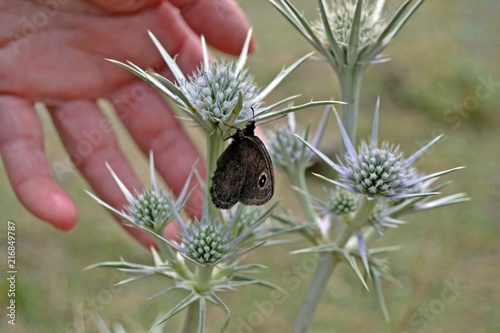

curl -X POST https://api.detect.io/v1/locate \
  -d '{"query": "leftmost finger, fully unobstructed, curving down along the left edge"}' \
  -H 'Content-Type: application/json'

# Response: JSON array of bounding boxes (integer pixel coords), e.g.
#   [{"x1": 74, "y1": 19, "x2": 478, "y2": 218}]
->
[{"x1": 0, "y1": 96, "x2": 78, "y2": 230}]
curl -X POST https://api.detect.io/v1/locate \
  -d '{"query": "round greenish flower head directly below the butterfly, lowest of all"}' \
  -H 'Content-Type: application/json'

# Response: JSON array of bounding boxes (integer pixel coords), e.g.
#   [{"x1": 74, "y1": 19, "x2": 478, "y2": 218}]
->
[{"x1": 182, "y1": 223, "x2": 231, "y2": 265}]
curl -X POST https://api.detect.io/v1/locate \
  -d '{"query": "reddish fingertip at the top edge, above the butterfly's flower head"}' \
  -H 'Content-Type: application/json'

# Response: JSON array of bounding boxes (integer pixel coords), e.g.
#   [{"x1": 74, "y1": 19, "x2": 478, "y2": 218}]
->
[{"x1": 170, "y1": 0, "x2": 256, "y2": 55}]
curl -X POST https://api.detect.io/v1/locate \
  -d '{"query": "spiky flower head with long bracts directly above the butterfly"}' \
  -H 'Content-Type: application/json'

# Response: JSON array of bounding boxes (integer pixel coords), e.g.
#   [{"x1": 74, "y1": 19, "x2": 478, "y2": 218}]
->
[{"x1": 108, "y1": 29, "x2": 336, "y2": 135}]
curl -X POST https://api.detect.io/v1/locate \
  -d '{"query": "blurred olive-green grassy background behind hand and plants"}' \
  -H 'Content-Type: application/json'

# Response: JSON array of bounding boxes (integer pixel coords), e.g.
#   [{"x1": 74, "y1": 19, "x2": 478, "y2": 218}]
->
[{"x1": 0, "y1": 0, "x2": 500, "y2": 333}]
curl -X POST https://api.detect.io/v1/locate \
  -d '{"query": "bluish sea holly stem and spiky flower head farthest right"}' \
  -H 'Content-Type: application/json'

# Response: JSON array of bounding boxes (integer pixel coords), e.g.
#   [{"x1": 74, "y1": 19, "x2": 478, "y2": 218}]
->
[{"x1": 286, "y1": 103, "x2": 468, "y2": 332}]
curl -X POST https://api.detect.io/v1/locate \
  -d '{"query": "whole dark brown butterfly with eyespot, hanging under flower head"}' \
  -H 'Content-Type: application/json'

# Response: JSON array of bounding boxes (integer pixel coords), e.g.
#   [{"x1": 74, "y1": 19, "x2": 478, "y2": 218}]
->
[{"x1": 210, "y1": 121, "x2": 274, "y2": 209}]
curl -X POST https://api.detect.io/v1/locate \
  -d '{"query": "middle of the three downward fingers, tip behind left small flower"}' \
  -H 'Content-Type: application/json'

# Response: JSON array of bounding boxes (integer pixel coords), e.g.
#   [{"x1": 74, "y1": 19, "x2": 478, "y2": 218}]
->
[{"x1": 49, "y1": 100, "x2": 153, "y2": 245}]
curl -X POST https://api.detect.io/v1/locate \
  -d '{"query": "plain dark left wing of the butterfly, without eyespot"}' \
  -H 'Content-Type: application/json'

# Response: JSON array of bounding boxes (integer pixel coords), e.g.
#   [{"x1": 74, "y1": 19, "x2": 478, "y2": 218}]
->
[{"x1": 210, "y1": 139, "x2": 248, "y2": 209}]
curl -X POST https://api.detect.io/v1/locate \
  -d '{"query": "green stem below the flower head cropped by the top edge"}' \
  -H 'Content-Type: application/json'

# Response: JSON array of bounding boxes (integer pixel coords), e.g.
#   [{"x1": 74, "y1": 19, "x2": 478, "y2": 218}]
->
[{"x1": 339, "y1": 65, "x2": 365, "y2": 158}]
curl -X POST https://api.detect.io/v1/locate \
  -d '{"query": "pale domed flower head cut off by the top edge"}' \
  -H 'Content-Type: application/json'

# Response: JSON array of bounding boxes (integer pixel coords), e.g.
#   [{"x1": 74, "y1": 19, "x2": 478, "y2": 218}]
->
[{"x1": 311, "y1": 0, "x2": 388, "y2": 47}]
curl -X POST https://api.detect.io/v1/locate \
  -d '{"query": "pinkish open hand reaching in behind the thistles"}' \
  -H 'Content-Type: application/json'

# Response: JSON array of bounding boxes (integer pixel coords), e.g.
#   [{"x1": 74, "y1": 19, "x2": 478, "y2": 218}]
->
[{"x1": 0, "y1": 0, "x2": 255, "y2": 244}]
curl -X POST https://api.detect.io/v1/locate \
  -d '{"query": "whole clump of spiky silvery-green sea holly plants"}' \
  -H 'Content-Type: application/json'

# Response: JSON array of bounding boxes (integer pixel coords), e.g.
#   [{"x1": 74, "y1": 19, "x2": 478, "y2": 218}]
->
[{"x1": 86, "y1": 0, "x2": 468, "y2": 333}]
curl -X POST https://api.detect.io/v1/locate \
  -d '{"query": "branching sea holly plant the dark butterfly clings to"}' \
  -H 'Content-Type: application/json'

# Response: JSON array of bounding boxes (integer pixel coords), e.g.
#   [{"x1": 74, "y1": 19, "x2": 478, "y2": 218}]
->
[{"x1": 89, "y1": 31, "x2": 337, "y2": 333}]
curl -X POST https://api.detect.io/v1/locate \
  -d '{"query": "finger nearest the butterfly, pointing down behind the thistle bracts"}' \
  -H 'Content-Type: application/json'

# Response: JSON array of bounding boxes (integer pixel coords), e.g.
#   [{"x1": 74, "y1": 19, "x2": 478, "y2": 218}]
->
[{"x1": 109, "y1": 81, "x2": 205, "y2": 217}]
